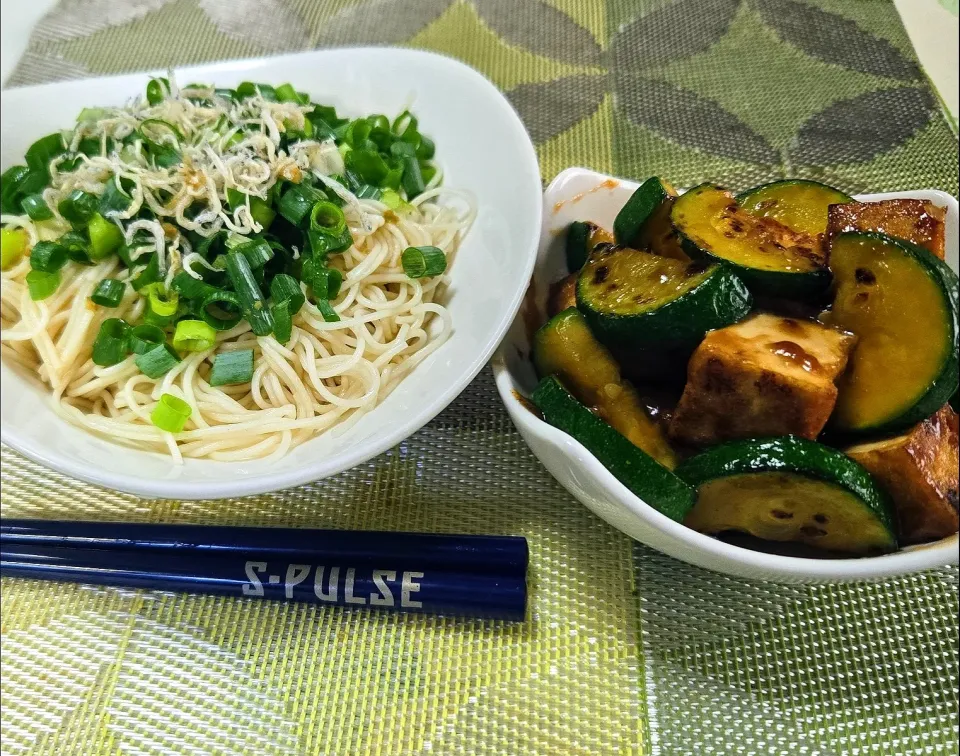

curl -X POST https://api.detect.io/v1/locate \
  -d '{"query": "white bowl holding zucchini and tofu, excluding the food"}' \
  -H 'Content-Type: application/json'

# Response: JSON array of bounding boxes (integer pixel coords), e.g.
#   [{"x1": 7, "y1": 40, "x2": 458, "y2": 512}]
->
[{"x1": 493, "y1": 168, "x2": 958, "y2": 583}]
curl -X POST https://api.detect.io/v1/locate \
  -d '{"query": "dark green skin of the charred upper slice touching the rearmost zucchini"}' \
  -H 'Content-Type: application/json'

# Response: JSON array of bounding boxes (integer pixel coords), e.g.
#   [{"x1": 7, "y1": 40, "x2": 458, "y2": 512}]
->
[{"x1": 670, "y1": 184, "x2": 832, "y2": 300}]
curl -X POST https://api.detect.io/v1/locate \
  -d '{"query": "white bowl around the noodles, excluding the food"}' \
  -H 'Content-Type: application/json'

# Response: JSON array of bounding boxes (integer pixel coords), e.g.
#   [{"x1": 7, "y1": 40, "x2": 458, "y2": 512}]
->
[{"x1": 0, "y1": 48, "x2": 542, "y2": 499}]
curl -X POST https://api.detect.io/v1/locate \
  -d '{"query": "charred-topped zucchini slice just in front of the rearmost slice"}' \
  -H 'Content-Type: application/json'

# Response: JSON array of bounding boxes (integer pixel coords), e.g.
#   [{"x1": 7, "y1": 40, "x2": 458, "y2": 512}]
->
[{"x1": 670, "y1": 184, "x2": 830, "y2": 299}]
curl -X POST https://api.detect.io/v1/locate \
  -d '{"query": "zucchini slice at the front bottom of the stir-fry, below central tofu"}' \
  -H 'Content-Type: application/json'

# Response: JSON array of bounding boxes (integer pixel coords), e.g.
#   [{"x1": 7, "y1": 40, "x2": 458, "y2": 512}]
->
[{"x1": 677, "y1": 436, "x2": 897, "y2": 554}]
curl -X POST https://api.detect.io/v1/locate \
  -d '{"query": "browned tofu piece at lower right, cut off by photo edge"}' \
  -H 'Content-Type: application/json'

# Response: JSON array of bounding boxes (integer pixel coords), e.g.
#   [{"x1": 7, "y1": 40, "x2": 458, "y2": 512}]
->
[{"x1": 846, "y1": 405, "x2": 960, "y2": 544}]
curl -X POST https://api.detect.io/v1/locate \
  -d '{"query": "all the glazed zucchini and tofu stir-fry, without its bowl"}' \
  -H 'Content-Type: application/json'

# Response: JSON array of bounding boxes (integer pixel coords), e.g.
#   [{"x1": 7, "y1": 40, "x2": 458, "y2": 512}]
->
[{"x1": 533, "y1": 178, "x2": 960, "y2": 556}]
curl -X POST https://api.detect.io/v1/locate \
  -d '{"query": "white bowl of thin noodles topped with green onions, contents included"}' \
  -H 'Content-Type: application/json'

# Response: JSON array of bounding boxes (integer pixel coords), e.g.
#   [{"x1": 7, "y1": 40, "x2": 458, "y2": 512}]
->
[{"x1": 0, "y1": 48, "x2": 541, "y2": 499}]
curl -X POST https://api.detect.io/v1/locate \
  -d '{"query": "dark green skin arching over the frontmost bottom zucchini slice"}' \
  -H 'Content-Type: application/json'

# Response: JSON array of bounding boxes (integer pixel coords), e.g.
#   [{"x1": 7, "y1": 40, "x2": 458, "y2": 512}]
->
[{"x1": 676, "y1": 436, "x2": 897, "y2": 541}]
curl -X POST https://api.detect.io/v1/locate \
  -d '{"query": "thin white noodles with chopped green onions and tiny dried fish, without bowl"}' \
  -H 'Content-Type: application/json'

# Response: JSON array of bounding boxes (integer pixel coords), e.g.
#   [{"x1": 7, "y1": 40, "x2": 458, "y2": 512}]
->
[{"x1": 0, "y1": 77, "x2": 475, "y2": 461}]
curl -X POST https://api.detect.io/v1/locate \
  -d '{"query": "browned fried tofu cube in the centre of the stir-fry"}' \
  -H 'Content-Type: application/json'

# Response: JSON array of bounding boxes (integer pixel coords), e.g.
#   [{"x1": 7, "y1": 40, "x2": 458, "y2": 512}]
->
[{"x1": 670, "y1": 313, "x2": 856, "y2": 446}]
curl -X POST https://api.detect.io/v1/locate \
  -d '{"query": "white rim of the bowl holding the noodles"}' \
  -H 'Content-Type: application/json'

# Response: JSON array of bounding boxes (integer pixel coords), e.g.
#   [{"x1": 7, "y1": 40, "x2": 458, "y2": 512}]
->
[{"x1": 0, "y1": 46, "x2": 543, "y2": 500}]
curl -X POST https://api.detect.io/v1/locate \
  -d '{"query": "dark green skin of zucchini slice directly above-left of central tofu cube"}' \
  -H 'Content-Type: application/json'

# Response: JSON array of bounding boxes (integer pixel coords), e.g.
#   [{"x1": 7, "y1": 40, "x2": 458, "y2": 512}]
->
[{"x1": 577, "y1": 255, "x2": 753, "y2": 349}]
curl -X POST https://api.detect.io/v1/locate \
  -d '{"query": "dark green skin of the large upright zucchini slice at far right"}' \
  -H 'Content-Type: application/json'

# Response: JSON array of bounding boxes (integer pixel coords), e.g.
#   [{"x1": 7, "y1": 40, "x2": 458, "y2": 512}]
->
[{"x1": 831, "y1": 231, "x2": 960, "y2": 437}]
